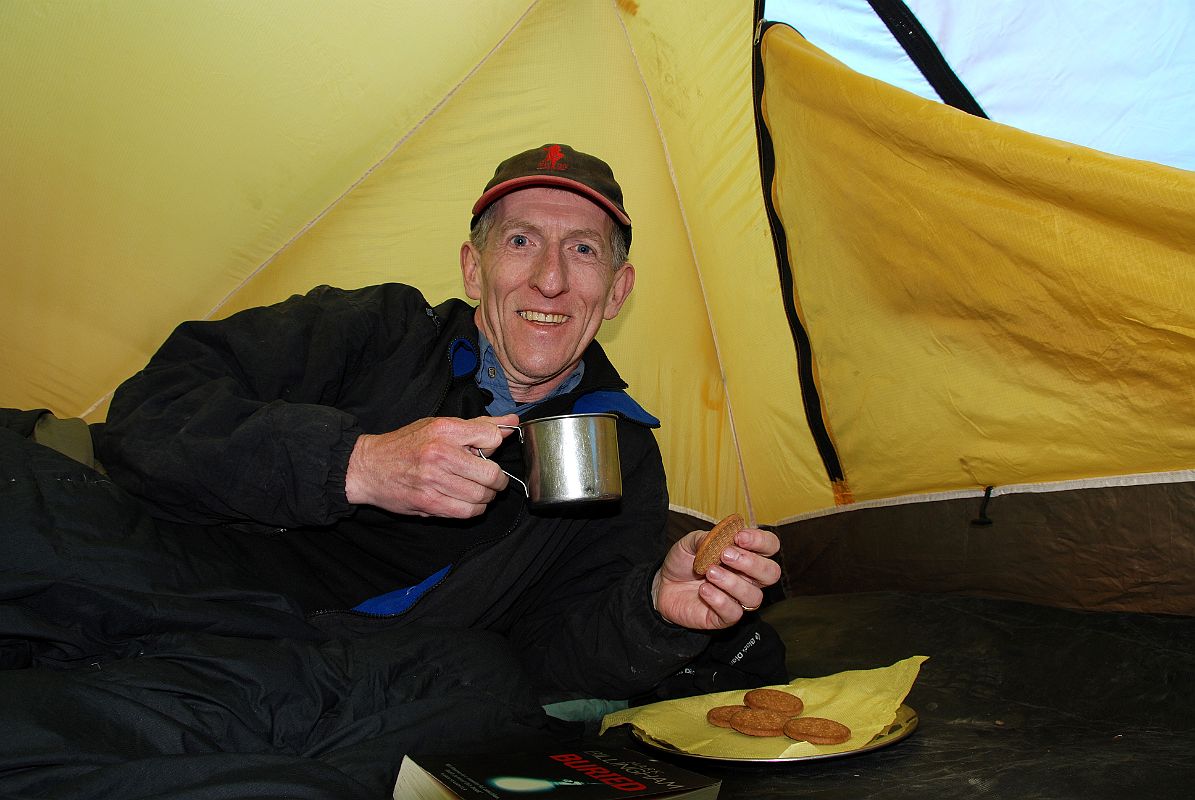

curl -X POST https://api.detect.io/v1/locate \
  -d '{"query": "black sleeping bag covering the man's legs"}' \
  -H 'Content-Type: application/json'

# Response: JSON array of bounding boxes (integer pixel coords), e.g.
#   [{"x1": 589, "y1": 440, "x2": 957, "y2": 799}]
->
[{"x1": 0, "y1": 413, "x2": 580, "y2": 800}]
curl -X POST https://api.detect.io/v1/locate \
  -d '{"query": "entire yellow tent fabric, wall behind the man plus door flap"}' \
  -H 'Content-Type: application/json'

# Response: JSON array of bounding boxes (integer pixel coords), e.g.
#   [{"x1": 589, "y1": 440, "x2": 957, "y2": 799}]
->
[{"x1": 0, "y1": 0, "x2": 1195, "y2": 524}]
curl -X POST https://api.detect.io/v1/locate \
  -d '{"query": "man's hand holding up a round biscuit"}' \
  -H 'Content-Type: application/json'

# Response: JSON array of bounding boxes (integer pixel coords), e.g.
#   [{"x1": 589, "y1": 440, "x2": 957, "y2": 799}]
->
[{"x1": 651, "y1": 527, "x2": 780, "y2": 630}]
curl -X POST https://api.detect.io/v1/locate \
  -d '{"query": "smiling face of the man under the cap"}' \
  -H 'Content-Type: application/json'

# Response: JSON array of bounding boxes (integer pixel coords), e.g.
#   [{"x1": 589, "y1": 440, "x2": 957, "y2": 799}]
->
[{"x1": 460, "y1": 188, "x2": 635, "y2": 402}]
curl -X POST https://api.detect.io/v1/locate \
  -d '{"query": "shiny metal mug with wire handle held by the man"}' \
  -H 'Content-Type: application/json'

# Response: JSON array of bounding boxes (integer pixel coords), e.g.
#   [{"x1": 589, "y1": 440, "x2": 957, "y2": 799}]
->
[{"x1": 478, "y1": 414, "x2": 623, "y2": 507}]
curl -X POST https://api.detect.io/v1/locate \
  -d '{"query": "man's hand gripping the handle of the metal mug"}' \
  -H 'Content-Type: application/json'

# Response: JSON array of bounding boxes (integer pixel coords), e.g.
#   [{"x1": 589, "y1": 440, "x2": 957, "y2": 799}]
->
[{"x1": 344, "y1": 414, "x2": 519, "y2": 519}]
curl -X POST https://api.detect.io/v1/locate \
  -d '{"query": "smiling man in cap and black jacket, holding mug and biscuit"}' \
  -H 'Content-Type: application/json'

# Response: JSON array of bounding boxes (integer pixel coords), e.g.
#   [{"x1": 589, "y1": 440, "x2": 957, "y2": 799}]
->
[{"x1": 102, "y1": 145, "x2": 778, "y2": 640}]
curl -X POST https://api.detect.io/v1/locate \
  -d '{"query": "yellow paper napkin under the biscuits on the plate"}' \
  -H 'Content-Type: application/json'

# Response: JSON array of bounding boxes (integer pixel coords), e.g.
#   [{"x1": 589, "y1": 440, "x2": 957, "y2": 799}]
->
[{"x1": 601, "y1": 655, "x2": 929, "y2": 758}]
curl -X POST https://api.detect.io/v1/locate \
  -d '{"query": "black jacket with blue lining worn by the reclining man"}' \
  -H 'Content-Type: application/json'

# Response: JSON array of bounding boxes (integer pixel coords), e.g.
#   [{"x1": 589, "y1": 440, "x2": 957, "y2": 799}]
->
[{"x1": 97, "y1": 283, "x2": 709, "y2": 697}]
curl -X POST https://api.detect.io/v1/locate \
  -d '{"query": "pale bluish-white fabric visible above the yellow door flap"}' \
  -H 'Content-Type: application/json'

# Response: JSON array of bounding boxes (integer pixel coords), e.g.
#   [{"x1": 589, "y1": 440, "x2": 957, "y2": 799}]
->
[{"x1": 767, "y1": 0, "x2": 1195, "y2": 170}]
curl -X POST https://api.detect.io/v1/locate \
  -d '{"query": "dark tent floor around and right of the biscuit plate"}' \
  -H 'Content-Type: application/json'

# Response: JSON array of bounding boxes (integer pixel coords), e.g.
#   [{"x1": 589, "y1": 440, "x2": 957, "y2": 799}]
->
[{"x1": 602, "y1": 593, "x2": 1195, "y2": 800}]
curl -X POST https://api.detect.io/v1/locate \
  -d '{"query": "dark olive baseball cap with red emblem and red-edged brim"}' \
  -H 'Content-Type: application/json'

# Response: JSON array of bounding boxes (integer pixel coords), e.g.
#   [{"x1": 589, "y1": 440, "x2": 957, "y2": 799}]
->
[{"x1": 470, "y1": 145, "x2": 631, "y2": 246}]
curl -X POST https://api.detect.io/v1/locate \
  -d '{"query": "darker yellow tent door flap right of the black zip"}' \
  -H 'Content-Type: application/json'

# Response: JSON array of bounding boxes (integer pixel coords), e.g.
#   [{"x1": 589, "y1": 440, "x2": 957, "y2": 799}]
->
[{"x1": 764, "y1": 28, "x2": 1195, "y2": 511}]
